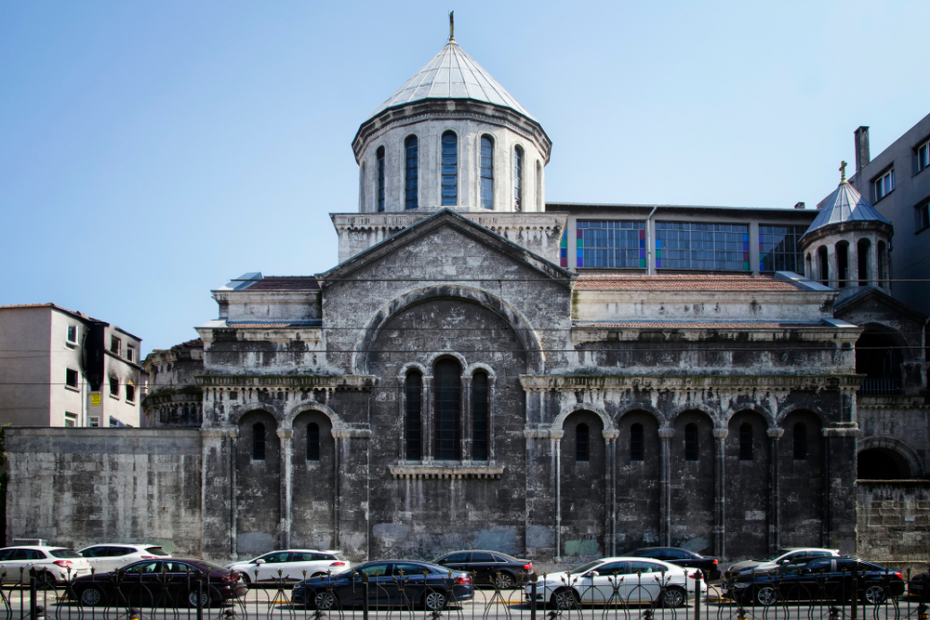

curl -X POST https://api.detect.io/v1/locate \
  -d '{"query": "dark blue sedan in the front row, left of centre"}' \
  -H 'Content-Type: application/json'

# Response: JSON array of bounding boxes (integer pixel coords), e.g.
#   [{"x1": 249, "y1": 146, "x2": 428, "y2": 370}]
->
[{"x1": 291, "y1": 560, "x2": 475, "y2": 611}]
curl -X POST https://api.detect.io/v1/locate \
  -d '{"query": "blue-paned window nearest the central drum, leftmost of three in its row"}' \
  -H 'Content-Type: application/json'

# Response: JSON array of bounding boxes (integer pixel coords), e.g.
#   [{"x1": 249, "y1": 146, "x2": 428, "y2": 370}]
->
[{"x1": 575, "y1": 220, "x2": 646, "y2": 269}]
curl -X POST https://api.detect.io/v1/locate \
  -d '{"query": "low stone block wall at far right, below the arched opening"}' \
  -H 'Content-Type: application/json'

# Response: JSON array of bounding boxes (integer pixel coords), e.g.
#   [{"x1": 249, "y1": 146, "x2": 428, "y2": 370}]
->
[{"x1": 856, "y1": 480, "x2": 930, "y2": 571}]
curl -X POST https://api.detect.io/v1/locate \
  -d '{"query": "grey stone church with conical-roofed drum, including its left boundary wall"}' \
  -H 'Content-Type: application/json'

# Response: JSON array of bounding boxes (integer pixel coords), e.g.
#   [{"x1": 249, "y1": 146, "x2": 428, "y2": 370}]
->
[{"x1": 7, "y1": 38, "x2": 930, "y2": 562}]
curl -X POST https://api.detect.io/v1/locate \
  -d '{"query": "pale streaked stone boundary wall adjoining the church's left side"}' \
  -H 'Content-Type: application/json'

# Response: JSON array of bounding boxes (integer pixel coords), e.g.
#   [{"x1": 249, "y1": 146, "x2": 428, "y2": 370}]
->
[{"x1": 6, "y1": 427, "x2": 202, "y2": 556}]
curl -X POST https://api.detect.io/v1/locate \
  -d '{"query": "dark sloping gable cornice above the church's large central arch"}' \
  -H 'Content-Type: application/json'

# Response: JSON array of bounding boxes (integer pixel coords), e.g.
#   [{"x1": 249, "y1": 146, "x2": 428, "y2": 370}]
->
[{"x1": 316, "y1": 209, "x2": 574, "y2": 288}]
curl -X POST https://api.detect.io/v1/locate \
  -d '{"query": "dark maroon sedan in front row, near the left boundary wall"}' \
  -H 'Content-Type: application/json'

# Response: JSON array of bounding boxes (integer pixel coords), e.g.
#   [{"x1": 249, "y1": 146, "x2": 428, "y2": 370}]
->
[{"x1": 73, "y1": 558, "x2": 248, "y2": 607}]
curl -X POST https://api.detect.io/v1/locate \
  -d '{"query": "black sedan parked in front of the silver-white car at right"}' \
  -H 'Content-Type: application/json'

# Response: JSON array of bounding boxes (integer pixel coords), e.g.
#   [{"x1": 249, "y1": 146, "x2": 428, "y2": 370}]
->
[{"x1": 726, "y1": 556, "x2": 904, "y2": 605}]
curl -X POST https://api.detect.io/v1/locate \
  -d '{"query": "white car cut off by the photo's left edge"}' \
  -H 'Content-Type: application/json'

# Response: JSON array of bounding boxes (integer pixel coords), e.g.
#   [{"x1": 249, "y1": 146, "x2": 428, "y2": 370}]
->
[{"x1": 0, "y1": 545, "x2": 90, "y2": 587}]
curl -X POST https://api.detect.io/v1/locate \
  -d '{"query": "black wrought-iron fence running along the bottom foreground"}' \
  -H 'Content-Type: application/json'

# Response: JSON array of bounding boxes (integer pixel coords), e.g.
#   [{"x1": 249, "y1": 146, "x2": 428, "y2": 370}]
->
[{"x1": 0, "y1": 571, "x2": 930, "y2": 620}]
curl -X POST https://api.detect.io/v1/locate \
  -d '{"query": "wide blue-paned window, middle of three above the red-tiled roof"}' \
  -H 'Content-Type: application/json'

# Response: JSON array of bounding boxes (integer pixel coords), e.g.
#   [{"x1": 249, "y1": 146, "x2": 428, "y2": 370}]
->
[{"x1": 656, "y1": 222, "x2": 749, "y2": 271}]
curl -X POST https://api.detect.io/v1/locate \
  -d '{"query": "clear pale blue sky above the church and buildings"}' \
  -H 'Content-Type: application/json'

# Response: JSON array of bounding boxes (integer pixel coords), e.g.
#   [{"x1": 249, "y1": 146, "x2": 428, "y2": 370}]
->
[{"x1": 0, "y1": 0, "x2": 930, "y2": 352}]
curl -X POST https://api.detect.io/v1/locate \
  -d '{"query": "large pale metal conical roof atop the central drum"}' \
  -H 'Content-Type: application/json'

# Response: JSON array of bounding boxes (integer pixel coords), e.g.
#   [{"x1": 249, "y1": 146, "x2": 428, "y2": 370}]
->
[{"x1": 369, "y1": 40, "x2": 536, "y2": 121}]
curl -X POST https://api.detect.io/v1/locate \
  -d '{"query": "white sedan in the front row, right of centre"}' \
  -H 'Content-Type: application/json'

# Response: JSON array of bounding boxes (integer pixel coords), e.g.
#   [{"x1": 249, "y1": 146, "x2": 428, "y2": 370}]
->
[{"x1": 526, "y1": 557, "x2": 707, "y2": 609}]
